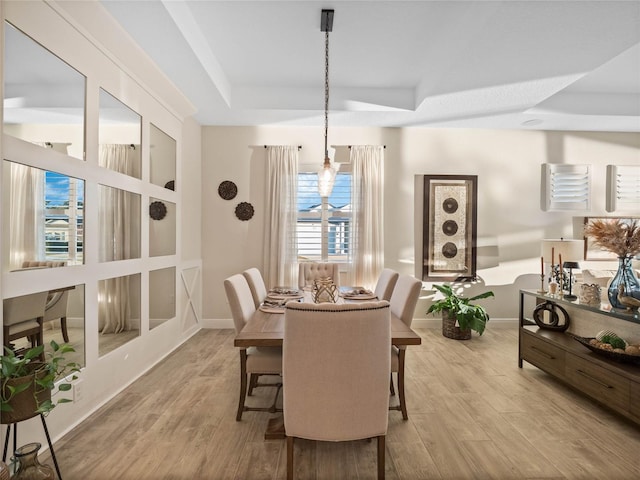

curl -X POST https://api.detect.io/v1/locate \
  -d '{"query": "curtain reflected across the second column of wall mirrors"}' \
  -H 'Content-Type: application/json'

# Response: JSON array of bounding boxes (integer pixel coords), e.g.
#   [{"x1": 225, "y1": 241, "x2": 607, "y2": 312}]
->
[{"x1": 98, "y1": 145, "x2": 135, "y2": 333}]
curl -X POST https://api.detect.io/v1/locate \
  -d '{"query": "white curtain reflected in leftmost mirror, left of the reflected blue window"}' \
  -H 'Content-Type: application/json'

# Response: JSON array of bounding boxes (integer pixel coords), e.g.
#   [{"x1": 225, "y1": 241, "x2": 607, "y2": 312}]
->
[{"x1": 5, "y1": 162, "x2": 45, "y2": 270}]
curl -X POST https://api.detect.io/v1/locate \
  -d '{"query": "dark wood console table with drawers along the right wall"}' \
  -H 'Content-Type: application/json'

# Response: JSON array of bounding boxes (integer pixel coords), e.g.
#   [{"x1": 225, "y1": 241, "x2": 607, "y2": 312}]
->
[{"x1": 518, "y1": 290, "x2": 640, "y2": 425}]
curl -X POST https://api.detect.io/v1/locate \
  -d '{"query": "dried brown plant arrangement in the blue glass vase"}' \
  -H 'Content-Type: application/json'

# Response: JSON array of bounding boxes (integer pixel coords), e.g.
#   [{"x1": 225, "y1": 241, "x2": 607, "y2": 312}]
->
[{"x1": 584, "y1": 218, "x2": 640, "y2": 258}]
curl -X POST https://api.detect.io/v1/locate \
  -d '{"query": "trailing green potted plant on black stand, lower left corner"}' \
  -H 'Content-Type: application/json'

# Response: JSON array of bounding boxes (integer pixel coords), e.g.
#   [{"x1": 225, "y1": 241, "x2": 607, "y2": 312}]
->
[{"x1": 0, "y1": 340, "x2": 80, "y2": 424}]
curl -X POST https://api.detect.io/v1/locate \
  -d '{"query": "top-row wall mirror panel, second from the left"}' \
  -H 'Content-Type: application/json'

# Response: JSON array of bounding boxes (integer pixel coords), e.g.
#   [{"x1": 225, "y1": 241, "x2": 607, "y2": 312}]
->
[{"x1": 98, "y1": 89, "x2": 142, "y2": 178}]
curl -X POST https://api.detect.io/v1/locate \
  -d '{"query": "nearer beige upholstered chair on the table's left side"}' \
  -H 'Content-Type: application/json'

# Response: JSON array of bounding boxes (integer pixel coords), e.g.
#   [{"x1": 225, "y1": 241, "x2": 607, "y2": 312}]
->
[{"x1": 224, "y1": 274, "x2": 282, "y2": 421}]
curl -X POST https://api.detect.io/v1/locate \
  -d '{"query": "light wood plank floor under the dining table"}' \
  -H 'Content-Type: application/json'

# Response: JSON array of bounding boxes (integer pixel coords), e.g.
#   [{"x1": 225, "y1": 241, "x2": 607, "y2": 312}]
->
[{"x1": 46, "y1": 327, "x2": 640, "y2": 480}]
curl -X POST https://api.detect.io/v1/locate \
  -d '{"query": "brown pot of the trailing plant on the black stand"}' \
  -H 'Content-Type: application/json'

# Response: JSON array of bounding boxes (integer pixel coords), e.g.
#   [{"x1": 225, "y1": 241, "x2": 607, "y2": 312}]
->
[{"x1": 0, "y1": 363, "x2": 51, "y2": 425}]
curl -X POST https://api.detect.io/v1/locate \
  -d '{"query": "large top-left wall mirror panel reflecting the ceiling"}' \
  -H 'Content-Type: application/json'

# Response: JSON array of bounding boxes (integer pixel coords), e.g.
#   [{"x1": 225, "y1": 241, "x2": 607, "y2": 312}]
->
[{"x1": 3, "y1": 22, "x2": 86, "y2": 159}]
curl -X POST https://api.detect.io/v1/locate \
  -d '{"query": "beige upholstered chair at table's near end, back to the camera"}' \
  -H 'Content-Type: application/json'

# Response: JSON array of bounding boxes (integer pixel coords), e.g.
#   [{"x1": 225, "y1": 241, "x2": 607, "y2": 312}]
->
[{"x1": 282, "y1": 301, "x2": 391, "y2": 479}]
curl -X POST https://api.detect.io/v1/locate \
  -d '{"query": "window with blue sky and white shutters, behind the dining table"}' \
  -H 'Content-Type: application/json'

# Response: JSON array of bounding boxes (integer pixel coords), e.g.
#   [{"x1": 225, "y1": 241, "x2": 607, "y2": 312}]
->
[{"x1": 296, "y1": 172, "x2": 351, "y2": 262}]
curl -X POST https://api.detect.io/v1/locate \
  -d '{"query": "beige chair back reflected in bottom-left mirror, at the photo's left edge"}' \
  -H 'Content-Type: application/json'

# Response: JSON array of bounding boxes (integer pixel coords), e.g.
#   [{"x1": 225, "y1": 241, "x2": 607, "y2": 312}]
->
[{"x1": 2, "y1": 292, "x2": 47, "y2": 354}]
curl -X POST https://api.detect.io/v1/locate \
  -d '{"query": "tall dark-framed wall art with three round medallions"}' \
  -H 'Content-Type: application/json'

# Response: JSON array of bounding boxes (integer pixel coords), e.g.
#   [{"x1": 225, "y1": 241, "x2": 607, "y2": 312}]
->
[{"x1": 422, "y1": 175, "x2": 478, "y2": 282}]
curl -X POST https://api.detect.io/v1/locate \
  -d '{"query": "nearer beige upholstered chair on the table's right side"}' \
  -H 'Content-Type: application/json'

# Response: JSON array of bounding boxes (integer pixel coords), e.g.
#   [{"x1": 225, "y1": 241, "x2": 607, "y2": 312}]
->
[{"x1": 389, "y1": 275, "x2": 422, "y2": 420}]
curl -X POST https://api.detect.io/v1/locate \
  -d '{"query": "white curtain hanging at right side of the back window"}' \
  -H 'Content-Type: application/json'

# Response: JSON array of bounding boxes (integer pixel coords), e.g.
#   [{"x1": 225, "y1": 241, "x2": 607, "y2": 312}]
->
[{"x1": 351, "y1": 145, "x2": 384, "y2": 288}]
